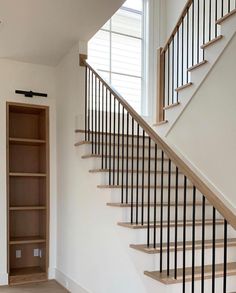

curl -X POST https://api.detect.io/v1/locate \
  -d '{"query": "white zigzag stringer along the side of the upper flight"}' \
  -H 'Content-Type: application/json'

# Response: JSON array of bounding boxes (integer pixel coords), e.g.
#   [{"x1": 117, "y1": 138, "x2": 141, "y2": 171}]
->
[{"x1": 153, "y1": 14, "x2": 236, "y2": 137}]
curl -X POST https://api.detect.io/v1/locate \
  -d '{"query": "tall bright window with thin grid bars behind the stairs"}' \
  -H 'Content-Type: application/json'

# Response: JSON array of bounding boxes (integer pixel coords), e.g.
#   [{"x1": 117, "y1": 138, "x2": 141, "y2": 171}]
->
[{"x1": 88, "y1": 0, "x2": 144, "y2": 113}]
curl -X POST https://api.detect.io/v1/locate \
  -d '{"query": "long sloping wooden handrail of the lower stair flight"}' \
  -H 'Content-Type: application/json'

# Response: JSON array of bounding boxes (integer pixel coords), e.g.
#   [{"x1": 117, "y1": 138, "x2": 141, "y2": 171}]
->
[{"x1": 84, "y1": 60, "x2": 236, "y2": 229}]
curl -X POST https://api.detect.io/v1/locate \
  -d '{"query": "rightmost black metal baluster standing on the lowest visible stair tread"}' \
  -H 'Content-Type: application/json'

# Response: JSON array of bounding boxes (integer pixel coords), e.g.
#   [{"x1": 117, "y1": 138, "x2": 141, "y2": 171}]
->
[{"x1": 175, "y1": 167, "x2": 179, "y2": 279}]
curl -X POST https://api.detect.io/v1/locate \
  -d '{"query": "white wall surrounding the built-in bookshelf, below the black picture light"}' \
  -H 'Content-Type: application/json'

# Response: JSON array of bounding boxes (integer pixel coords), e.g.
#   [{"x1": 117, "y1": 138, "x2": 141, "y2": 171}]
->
[{"x1": 0, "y1": 59, "x2": 56, "y2": 285}]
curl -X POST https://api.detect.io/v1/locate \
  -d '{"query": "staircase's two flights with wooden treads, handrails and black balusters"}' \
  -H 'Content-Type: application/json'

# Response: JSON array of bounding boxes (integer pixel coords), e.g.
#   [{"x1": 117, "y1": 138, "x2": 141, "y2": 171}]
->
[{"x1": 76, "y1": 0, "x2": 236, "y2": 293}]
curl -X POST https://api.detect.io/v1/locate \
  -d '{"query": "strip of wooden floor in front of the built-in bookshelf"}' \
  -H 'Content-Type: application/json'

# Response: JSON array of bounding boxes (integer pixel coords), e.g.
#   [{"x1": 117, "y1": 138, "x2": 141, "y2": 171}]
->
[{"x1": 0, "y1": 281, "x2": 69, "y2": 293}]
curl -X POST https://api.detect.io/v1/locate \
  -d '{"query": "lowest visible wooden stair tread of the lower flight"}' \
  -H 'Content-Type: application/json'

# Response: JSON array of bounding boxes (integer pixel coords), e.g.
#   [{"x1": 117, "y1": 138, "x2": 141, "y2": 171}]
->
[{"x1": 144, "y1": 262, "x2": 236, "y2": 285}]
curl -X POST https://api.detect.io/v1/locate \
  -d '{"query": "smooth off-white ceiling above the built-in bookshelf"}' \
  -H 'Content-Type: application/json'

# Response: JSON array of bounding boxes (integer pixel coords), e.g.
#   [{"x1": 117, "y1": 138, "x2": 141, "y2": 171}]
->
[{"x1": 0, "y1": 0, "x2": 124, "y2": 66}]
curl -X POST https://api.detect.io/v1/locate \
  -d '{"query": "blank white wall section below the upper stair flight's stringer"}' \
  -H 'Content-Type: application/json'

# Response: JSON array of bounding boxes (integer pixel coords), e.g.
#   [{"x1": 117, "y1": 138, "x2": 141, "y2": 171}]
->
[{"x1": 167, "y1": 35, "x2": 236, "y2": 211}]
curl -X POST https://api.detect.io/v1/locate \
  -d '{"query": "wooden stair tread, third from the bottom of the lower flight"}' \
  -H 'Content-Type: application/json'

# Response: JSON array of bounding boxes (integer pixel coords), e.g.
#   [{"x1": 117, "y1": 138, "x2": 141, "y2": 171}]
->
[{"x1": 118, "y1": 219, "x2": 224, "y2": 229}]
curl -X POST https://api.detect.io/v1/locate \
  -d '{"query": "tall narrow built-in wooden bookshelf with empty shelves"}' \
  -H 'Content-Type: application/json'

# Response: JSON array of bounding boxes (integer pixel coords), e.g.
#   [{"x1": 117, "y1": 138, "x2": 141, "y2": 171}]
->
[{"x1": 7, "y1": 103, "x2": 49, "y2": 285}]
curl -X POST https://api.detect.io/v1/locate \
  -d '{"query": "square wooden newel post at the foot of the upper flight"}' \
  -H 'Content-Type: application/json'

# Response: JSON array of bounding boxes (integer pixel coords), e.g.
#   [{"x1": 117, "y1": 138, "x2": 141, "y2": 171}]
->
[{"x1": 157, "y1": 48, "x2": 165, "y2": 123}]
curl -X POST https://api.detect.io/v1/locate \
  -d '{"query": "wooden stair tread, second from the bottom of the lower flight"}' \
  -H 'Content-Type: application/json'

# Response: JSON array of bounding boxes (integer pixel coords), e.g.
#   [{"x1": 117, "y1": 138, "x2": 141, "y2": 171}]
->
[{"x1": 130, "y1": 238, "x2": 236, "y2": 254}]
